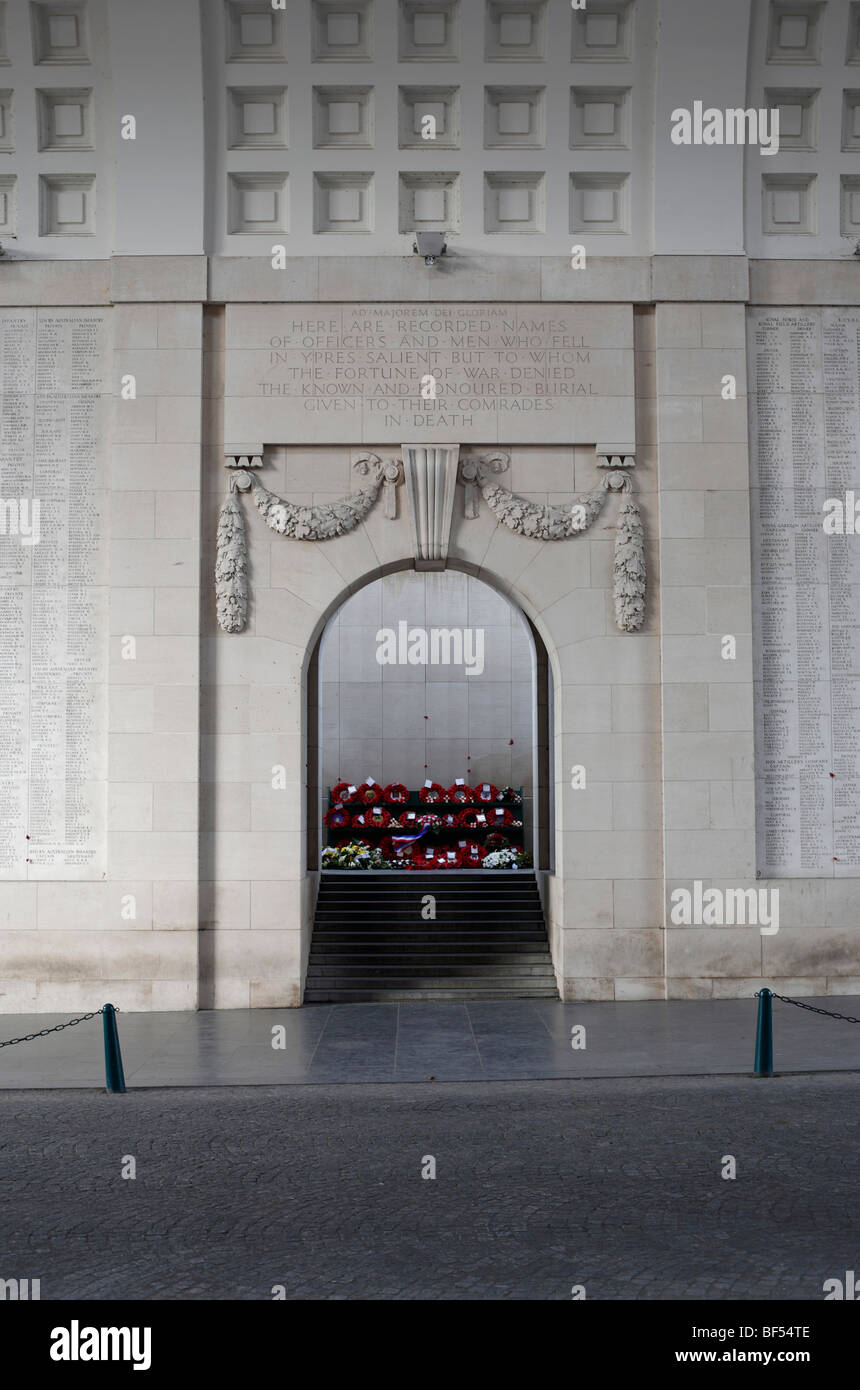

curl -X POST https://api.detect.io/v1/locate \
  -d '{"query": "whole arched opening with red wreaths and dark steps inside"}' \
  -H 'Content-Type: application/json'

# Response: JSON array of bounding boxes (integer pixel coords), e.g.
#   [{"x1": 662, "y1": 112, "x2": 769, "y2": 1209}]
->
[{"x1": 303, "y1": 566, "x2": 559, "y2": 1004}]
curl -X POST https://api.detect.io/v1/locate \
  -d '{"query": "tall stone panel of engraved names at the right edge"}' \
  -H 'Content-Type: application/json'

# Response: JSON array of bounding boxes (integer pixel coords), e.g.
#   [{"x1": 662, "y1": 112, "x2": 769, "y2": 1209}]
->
[{"x1": 749, "y1": 309, "x2": 860, "y2": 877}]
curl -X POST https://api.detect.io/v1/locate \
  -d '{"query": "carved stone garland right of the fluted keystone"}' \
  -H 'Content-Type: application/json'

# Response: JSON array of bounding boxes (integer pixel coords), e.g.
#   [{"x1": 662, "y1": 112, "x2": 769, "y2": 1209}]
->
[{"x1": 460, "y1": 453, "x2": 646, "y2": 632}]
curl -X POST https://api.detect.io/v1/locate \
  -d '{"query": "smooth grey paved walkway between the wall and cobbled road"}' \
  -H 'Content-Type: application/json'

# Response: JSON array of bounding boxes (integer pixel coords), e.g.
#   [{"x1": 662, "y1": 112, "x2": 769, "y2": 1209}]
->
[{"x1": 0, "y1": 995, "x2": 860, "y2": 1088}]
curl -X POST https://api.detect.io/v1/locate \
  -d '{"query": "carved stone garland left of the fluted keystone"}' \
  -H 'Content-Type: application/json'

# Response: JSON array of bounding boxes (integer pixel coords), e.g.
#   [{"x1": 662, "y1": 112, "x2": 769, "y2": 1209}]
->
[{"x1": 215, "y1": 453, "x2": 403, "y2": 632}]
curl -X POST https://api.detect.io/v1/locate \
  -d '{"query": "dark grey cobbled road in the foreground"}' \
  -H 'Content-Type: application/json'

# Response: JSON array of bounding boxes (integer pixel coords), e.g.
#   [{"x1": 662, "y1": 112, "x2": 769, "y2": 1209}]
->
[{"x1": 0, "y1": 1074, "x2": 860, "y2": 1301}]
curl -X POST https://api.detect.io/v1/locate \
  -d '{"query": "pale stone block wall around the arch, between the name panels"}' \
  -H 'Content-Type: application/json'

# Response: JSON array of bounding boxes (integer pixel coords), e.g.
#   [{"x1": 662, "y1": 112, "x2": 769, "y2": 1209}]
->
[{"x1": 0, "y1": 257, "x2": 860, "y2": 1011}]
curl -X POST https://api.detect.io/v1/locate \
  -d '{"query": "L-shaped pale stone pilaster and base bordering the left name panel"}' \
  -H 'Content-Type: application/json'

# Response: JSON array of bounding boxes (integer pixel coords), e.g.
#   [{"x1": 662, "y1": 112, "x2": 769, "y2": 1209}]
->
[{"x1": 0, "y1": 303, "x2": 203, "y2": 1012}]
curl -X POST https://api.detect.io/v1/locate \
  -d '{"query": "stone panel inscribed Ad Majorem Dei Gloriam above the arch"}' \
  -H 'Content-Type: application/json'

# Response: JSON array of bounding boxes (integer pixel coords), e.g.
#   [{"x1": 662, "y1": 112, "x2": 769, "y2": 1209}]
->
[{"x1": 225, "y1": 303, "x2": 635, "y2": 445}]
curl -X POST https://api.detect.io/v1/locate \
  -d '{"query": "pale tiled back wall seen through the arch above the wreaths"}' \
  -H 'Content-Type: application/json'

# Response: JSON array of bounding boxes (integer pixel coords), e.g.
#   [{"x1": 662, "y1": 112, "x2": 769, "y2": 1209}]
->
[{"x1": 307, "y1": 566, "x2": 554, "y2": 872}]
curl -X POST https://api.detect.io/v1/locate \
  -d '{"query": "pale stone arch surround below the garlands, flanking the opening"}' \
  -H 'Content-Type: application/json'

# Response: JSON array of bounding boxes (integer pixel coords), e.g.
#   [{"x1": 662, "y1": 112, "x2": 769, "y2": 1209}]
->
[{"x1": 200, "y1": 448, "x2": 664, "y2": 1008}]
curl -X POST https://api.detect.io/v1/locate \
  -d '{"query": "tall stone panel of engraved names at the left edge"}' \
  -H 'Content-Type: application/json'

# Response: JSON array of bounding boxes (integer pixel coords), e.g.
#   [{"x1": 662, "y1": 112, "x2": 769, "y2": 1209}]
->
[{"x1": 0, "y1": 309, "x2": 107, "y2": 878}]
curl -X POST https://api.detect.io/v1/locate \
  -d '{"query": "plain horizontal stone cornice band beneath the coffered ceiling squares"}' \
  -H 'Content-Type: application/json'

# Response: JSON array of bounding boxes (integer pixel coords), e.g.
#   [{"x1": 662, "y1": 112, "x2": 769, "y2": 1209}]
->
[{"x1": 0, "y1": 258, "x2": 860, "y2": 309}]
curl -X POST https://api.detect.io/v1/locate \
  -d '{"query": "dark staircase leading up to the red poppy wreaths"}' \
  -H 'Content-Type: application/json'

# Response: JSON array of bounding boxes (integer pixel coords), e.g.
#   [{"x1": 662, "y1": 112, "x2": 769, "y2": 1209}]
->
[{"x1": 304, "y1": 870, "x2": 559, "y2": 1004}]
